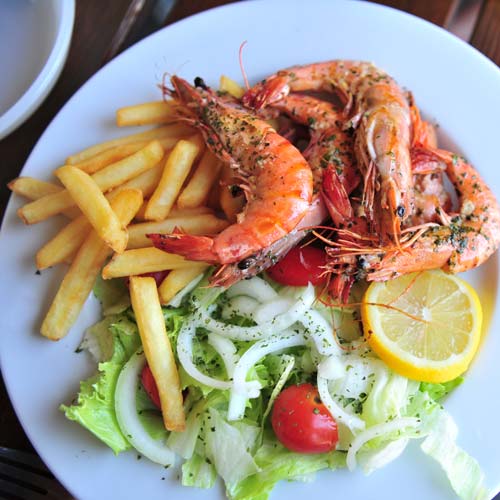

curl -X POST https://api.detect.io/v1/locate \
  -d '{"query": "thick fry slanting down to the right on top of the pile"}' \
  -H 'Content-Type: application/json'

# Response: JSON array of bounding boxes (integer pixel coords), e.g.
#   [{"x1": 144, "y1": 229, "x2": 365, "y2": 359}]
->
[{"x1": 56, "y1": 165, "x2": 128, "y2": 253}]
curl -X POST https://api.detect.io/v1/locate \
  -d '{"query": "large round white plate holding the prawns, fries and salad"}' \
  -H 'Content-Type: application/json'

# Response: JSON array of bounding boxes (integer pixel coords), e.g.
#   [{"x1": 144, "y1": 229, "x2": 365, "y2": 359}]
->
[{"x1": 0, "y1": 0, "x2": 500, "y2": 500}]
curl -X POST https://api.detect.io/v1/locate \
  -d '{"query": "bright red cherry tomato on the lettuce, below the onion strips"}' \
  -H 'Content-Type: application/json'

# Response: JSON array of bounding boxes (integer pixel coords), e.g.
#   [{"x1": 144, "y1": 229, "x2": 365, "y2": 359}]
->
[{"x1": 271, "y1": 384, "x2": 339, "y2": 453}]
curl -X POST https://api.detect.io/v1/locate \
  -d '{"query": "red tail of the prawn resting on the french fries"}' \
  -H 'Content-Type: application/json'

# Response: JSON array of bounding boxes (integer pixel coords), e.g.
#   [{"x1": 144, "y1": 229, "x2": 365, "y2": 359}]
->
[{"x1": 147, "y1": 233, "x2": 219, "y2": 264}]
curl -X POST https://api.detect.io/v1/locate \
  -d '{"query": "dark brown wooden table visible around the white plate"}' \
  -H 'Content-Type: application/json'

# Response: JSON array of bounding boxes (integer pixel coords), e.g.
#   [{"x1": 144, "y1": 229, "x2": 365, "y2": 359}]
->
[{"x1": 0, "y1": 0, "x2": 500, "y2": 498}]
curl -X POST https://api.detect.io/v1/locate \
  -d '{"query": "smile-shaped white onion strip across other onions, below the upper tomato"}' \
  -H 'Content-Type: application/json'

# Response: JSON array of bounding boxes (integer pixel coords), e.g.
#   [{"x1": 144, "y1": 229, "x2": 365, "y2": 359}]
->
[{"x1": 197, "y1": 284, "x2": 315, "y2": 341}]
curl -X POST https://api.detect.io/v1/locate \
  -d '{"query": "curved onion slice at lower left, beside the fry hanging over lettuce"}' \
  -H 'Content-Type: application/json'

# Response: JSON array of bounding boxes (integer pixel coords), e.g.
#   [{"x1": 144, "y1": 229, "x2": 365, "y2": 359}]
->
[{"x1": 115, "y1": 349, "x2": 175, "y2": 466}]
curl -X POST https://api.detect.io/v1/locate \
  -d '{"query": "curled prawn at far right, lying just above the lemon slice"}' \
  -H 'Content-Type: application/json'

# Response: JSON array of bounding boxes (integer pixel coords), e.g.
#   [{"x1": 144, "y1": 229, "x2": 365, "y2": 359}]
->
[{"x1": 327, "y1": 149, "x2": 500, "y2": 281}]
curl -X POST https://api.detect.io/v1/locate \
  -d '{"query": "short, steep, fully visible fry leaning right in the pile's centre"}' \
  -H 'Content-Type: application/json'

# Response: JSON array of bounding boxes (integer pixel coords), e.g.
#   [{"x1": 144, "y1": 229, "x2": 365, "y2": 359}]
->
[{"x1": 145, "y1": 136, "x2": 203, "y2": 221}]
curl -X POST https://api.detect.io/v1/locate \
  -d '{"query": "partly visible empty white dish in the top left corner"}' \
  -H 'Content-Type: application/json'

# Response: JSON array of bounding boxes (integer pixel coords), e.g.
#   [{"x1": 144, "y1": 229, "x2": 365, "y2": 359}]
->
[{"x1": 0, "y1": 0, "x2": 75, "y2": 139}]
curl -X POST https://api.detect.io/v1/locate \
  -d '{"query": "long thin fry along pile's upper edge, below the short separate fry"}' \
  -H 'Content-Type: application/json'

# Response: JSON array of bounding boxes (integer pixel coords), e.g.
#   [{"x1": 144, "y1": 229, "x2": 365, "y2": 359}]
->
[{"x1": 66, "y1": 123, "x2": 193, "y2": 165}]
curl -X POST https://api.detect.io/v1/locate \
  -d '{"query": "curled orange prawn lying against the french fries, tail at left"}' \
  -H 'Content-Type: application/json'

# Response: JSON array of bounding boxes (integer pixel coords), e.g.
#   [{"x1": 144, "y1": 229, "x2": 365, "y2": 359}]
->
[{"x1": 149, "y1": 76, "x2": 313, "y2": 264}]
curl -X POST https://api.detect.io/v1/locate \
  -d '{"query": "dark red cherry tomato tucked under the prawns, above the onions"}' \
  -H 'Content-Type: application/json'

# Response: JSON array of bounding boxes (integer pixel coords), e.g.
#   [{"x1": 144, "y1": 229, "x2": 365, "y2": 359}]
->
[{"x1": 267, "y1": 246, "x2": 326, "y2": 286}]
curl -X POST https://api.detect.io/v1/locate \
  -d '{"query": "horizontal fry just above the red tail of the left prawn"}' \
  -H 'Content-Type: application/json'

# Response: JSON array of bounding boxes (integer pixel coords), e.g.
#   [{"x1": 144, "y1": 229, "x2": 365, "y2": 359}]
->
[{"x1": 127, "y1": 214, "x2": 229, "y2": 250}]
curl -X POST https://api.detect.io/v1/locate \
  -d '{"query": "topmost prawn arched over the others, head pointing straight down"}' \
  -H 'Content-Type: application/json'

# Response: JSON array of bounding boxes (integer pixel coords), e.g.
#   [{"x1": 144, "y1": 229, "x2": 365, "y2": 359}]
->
[{"x1": 243, "y1": 60, "x2": 413, "y2": 242}]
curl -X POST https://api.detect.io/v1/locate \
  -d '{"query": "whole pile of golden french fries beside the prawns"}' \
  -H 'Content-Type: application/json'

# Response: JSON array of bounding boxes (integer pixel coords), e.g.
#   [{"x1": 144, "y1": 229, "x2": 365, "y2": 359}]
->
[{"x1": 9, "y1": 77, "x2": 244, "y2": 431}]
